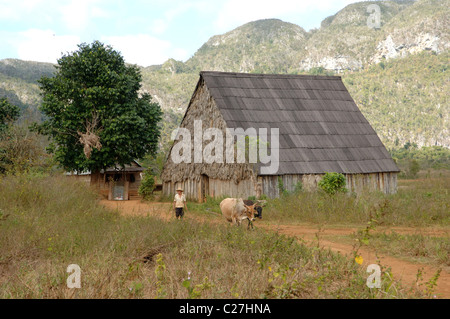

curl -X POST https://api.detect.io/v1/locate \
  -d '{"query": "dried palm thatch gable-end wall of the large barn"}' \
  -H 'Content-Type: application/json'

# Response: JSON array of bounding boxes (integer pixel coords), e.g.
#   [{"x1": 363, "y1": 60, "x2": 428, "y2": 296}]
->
[{"x1": 161, "y1": 81, "x2": 256, "y2": 201}]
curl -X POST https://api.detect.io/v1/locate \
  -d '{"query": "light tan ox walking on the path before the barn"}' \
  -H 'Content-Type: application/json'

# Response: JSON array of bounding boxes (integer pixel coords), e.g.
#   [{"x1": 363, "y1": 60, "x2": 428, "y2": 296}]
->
[{"x1": 220, "y1": 198, "x2": 256, "y2": 229}]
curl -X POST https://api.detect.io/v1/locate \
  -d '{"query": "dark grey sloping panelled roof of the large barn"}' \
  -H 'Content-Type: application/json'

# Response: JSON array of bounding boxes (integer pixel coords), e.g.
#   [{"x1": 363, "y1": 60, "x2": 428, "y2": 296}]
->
[{"x1": 197, "y1": 72, "x2": 399, "y2": 175}]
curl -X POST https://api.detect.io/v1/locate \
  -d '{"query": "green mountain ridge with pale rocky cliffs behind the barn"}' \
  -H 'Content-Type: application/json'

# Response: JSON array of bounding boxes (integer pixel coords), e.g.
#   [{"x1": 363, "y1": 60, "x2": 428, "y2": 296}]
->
[{"x1": 0, "y1": 0, "x2": 450, "y2": 147}]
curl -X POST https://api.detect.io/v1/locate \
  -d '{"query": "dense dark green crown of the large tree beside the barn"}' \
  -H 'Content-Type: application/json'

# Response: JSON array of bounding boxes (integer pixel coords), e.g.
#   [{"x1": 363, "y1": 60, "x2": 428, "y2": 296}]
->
[{"x1": 37, "y1": 41, "x2": 162, "y2": 172}]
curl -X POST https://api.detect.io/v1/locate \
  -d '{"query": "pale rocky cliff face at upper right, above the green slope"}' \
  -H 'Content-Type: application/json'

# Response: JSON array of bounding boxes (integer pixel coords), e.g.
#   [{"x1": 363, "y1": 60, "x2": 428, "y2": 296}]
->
[{"x1": 299, "y1": 0, "x2": 450, "y2": 72}]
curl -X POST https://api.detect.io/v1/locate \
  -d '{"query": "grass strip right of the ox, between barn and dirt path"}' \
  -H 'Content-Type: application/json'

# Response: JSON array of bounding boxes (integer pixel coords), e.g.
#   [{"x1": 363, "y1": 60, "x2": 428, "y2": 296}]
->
[{"x1": 264, "y1": 176, "x2": 450, "y2": 226}]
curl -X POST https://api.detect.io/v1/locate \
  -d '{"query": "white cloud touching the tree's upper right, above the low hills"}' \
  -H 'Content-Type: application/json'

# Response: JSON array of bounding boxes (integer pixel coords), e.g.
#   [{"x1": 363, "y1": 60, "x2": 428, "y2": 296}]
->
[{"x1": 101, "y1": 34, "x2": 187, "y2": 66}]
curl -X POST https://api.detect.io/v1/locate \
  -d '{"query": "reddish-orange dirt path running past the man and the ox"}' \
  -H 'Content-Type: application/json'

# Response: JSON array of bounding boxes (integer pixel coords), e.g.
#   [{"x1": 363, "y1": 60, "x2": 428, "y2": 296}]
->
[{"x1": 101, "y1": 200, "x2": 450, "y2": 299}]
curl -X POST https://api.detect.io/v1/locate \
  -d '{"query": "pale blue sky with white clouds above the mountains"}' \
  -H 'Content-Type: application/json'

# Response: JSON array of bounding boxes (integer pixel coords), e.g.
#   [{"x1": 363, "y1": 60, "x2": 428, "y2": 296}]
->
[{"x1": 0, "y1": 0, "x2": 360, "y2": 67}]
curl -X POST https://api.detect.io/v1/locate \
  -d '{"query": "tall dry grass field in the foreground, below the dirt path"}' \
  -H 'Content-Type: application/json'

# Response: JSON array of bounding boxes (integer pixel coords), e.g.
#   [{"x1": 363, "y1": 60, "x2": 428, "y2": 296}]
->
[{"x1": 0, "y1": 176, "x2": 428, "y2": 298}]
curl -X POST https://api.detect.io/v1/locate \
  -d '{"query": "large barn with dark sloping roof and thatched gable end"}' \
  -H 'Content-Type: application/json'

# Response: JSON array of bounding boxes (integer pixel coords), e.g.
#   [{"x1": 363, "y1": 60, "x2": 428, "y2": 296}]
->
[{"x1": 161, "y1": 72, "x2": 399, "y2": 201}]
